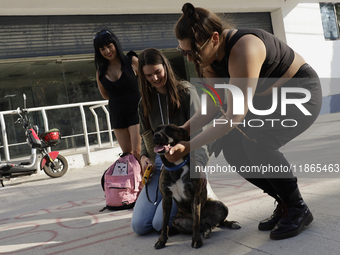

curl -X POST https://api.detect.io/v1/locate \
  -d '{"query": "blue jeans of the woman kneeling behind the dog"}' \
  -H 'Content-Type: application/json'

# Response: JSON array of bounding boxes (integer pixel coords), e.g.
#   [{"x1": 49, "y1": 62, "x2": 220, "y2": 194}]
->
[{"x1": 131, "y1": 155, "x2": 178, "y2": 235}]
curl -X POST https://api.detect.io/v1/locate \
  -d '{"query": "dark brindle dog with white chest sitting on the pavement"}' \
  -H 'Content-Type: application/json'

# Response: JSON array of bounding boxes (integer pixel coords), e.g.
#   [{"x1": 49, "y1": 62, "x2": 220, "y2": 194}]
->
[{"x1": 153, "y1": 124, "x2": 241, "y2": 249}]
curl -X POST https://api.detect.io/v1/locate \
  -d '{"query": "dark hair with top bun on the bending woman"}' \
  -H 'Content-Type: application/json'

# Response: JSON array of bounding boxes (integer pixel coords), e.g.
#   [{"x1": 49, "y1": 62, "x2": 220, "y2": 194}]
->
[{"x1": 174, "y1": 3, "x2": 227, "y2": 78}]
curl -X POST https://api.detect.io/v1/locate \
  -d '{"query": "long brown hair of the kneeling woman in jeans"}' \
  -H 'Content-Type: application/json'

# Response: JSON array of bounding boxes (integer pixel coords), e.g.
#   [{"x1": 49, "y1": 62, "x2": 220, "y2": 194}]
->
[{"x1": 138, "y1": 48, "x2": 185, "y2": 116}]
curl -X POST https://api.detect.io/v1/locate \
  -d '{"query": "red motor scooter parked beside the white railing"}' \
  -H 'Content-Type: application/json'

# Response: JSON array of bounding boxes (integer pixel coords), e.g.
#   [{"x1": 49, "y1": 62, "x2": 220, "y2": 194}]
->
[{"x1": 0, "y1": 94, "x2": 68, "y2": 187}]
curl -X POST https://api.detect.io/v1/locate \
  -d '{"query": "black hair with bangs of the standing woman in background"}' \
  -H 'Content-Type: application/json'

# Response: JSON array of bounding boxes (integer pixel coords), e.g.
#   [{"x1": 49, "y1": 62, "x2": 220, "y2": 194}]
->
[{"x1": 93, "y1": 29, "x2": 127, "y2": 75}]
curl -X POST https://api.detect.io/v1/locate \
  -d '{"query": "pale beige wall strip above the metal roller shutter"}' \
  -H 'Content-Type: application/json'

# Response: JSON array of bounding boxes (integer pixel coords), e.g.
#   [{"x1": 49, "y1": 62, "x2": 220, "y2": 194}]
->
[{"x1": 0, "y1": 0, "x2": 284, "y2": 15}]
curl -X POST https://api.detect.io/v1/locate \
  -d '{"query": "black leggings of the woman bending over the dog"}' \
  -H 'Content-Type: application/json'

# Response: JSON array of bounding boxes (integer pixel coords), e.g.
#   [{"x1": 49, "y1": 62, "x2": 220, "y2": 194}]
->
[{"x1": 221, "y1": 64, "x2": 322, "y2": 199}]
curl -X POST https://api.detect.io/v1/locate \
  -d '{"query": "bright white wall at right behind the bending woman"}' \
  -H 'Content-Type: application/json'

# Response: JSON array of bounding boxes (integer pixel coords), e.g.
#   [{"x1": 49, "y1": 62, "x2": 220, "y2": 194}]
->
[{"x1": 283, "y1": 1, "x2": 340, "y2": 96}]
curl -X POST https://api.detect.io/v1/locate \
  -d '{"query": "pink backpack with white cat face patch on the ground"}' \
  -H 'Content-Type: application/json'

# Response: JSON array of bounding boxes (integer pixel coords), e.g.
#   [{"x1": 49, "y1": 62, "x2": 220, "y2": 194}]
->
[{"x1": 101, "y1": 153, "x2": 142, "y2": 211}]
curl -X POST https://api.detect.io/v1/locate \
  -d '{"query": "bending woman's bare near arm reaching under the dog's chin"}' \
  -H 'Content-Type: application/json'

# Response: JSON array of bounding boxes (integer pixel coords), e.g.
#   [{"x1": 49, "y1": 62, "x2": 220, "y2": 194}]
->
[{"x1": 166, "y1": 35, "x2": 266, "y2": 162}]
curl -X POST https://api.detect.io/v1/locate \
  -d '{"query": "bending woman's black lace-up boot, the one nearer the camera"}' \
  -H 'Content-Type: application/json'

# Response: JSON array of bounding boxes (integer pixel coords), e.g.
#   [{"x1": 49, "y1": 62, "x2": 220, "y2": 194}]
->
[{"x1": 270, "y1": 188, "x2": 314, "y2": 240}]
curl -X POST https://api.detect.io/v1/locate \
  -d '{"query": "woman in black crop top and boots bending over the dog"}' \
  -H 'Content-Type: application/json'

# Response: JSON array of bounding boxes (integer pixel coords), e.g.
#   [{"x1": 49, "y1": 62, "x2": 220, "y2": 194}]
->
[{"x1": 167, "y1": 3, "x2": 322, "y2": 239}]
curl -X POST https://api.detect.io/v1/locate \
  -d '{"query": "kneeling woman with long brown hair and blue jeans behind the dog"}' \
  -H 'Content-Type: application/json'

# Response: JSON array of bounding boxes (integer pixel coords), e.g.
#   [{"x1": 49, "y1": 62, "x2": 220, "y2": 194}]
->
[{"x1": 131, "y1": 48, "x2": 208, "y2": 235}]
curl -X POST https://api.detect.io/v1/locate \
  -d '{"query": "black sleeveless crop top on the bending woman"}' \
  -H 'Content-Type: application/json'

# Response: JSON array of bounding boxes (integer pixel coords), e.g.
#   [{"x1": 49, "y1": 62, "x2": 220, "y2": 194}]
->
[{"x1": 211, "y1": 28, "x2": 294, "y2": 93}]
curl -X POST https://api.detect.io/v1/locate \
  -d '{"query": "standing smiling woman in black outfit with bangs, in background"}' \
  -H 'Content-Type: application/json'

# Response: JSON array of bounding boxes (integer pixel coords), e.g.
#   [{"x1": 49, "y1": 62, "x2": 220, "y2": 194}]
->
[{"x1": 93, "y1": 30, "x2": 141, "y2": 160}]
